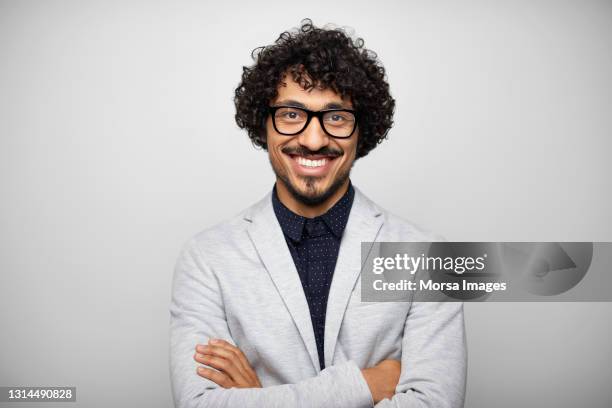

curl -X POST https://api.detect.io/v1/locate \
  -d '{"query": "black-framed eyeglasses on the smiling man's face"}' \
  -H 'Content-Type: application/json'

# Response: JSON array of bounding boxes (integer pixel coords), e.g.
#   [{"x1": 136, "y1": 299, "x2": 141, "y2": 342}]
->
[{"x1": 268, "y1": 106, "x2": 357, "y2": 139}]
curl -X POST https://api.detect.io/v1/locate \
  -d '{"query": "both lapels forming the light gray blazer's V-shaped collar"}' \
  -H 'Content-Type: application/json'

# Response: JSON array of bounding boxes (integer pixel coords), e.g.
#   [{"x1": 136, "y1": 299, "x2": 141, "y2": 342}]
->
[{"x1": 244, "y1": 187, "x2": 383, "y2": 372}]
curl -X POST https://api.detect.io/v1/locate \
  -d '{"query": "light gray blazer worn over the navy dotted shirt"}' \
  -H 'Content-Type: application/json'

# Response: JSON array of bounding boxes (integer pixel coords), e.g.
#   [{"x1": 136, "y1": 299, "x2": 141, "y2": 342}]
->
[{"x1": 170, "y1": 189, "x2": 467, "y2": 408}]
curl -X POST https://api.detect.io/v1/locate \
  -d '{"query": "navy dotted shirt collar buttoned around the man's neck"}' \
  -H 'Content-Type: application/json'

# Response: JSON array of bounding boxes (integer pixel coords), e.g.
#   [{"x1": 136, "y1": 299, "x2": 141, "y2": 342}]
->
[{"x1": 272, "y1": 182, "x2": 355, "y2": 242}]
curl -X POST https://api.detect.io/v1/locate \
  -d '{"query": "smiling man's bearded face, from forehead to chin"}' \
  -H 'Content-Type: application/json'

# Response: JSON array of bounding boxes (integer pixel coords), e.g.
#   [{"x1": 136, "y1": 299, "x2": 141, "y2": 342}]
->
[{"x1": 266, "y1": 76, "x2": 359, "y2": 205}]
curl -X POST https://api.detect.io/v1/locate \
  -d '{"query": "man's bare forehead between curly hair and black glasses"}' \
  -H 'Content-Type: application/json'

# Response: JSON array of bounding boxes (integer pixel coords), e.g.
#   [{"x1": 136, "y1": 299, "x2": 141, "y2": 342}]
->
[{"x1": 272, "y1": 75, "x2": 353, "y2": 110}]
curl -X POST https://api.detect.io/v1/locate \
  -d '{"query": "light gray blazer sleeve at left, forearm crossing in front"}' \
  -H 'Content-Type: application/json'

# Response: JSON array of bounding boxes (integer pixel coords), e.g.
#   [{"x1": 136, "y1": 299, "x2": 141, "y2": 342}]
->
[{"x1": 170, "y1": 239, "x2": 373, "y2": 408}]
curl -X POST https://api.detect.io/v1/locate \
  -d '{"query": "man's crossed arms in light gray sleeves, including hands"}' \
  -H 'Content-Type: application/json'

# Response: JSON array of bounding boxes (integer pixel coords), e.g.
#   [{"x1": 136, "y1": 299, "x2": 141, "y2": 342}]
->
[{"x1": 170, "y1": 241, "x2": 466, "y2": 408}]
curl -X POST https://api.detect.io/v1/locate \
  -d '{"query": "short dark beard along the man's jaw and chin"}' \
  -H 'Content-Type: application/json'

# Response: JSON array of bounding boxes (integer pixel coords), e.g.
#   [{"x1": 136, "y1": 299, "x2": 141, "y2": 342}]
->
[{"x1": 270, "y1": 147, "x2": 354, "y2": 207}]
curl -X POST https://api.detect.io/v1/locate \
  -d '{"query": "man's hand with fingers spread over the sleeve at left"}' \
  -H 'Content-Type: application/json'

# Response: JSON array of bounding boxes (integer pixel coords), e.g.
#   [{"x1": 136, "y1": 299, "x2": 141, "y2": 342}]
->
[{"x1": 193, "y1": 340, "x2": 261, "y2": 388}]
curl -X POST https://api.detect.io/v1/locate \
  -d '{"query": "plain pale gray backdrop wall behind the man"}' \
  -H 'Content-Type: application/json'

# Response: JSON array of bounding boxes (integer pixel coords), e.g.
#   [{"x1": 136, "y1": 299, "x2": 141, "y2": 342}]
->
[{"x1": 0, "y1": 0, "x2": 612, "y2": 407}]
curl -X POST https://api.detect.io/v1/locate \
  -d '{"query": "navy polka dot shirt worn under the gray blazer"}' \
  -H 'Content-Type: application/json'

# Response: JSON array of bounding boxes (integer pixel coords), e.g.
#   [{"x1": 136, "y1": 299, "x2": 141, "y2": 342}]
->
[{"x1": 272, "y1": 184, "x2": 355, "y2": 370}]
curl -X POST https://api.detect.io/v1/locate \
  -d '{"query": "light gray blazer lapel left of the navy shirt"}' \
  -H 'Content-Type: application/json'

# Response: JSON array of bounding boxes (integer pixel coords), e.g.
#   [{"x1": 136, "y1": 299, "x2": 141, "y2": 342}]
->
[{"x1": 245, "y1": 194, "x2": 321, "y2": 372}]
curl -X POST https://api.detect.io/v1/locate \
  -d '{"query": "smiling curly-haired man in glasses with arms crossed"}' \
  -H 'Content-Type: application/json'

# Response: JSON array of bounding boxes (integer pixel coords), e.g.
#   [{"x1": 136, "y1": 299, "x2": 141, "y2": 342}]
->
[{"x1": 170, "y1": 20, "x2": 466, "y2": 408}]
